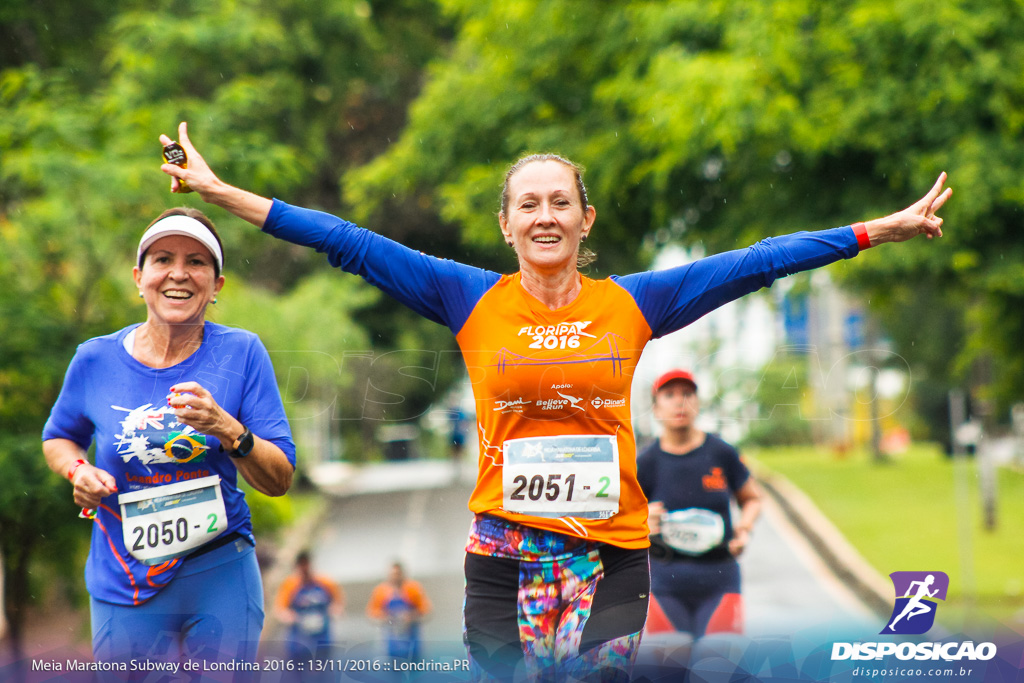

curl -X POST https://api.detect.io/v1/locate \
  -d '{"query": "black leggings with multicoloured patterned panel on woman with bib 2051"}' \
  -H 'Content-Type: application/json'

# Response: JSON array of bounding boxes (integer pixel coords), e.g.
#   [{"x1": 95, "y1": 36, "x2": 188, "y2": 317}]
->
[{"x1": 464, "y1": 518, "x2": 650, "y2": 681}]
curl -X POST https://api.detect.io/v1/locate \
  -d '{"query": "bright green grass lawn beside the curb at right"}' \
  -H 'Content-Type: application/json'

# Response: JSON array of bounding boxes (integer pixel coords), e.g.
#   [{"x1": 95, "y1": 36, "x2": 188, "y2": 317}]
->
[{"x1": 746, "y1": 445, "x2": 1024, "y2": 632}]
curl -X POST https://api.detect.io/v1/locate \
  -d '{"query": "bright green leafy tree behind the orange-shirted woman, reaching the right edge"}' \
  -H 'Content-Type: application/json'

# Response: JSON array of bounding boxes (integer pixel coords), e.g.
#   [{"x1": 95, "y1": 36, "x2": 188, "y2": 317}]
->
[{"x1": 345, "y1": 0, "x2": 1024, "y2": 436}]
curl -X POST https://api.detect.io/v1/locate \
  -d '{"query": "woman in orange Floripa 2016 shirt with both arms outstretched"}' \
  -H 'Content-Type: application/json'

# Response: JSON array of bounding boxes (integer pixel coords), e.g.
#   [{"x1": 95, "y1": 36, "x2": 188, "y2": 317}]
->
[{"x1": 161, "y1": 124, "x2": 952, "y2": 680}]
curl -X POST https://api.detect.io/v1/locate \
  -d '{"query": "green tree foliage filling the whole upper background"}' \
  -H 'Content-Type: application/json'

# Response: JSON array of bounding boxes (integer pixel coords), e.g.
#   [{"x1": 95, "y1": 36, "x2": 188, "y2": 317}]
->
[{"x1": 6, "y1": 0, "x2": 1024, "y2": 643}]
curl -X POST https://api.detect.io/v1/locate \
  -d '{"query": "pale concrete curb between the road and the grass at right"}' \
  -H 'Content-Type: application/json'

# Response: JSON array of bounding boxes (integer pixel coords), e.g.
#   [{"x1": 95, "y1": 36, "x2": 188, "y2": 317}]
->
[{"x1": 756, "y1": 464, "x2": 892, "y2": 620}]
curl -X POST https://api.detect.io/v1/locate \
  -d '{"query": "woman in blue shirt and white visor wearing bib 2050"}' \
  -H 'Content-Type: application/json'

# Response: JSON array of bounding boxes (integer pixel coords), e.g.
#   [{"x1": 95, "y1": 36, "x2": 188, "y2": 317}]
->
[{"x1": 43, "y1": 208, "x2": 295, "y2": 663}]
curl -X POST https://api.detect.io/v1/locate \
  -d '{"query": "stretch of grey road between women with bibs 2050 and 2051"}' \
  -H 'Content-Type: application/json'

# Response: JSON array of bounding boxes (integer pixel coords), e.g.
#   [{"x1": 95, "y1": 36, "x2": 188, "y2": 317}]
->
[{"x1": 268, "y1": 461, "x2": 472, "y2": 657}]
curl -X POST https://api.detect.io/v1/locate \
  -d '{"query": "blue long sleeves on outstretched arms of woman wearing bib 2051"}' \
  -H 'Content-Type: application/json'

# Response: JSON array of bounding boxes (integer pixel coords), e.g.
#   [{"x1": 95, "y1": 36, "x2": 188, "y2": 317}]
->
[{"x1": 263, "y1": 200, "x2": 859, "y2": 337}]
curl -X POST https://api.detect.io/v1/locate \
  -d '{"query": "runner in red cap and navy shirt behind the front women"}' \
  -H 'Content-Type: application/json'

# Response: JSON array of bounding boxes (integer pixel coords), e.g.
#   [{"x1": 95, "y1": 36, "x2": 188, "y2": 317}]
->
[{"x1": 637, "y1": 370, "x2": 761, "y2": 640}]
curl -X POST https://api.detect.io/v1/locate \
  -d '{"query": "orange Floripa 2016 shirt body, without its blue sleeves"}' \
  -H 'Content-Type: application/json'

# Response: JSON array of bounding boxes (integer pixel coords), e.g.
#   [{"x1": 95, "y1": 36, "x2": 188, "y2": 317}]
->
[{"x1": 456, "y1": 273, "x2": 651, "y2": 548}]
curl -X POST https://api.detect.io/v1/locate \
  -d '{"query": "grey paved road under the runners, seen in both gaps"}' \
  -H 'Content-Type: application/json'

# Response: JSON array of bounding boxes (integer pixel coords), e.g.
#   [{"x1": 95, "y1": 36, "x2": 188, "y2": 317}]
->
[{"x1": 270, "y1": 462, "x2": 878, "y2": 656}]
